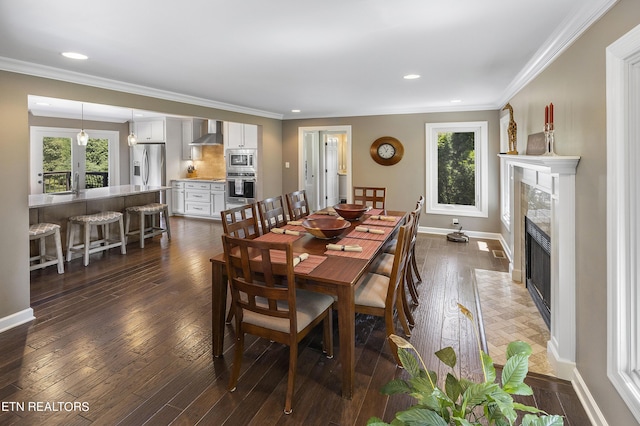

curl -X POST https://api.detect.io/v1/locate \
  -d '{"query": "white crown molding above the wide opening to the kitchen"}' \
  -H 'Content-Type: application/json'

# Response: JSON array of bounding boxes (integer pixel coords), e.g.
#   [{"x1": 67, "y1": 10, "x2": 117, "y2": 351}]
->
[{"x1": 0, "y1": 57, "x2": 283, "y2": 120}]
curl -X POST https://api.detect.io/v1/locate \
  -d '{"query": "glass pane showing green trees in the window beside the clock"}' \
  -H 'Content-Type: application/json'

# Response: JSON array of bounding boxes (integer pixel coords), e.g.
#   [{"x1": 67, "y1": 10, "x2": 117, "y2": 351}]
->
[{"x1": 438, "y1": 132, "x2": 476, "y2": 206}]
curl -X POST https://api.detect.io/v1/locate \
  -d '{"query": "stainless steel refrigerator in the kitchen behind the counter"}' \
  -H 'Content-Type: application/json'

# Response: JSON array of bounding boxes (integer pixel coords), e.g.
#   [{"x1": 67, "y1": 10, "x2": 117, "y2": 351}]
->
[{"x1": 131, "y1": 143, "x2": 166, "y2": 186}]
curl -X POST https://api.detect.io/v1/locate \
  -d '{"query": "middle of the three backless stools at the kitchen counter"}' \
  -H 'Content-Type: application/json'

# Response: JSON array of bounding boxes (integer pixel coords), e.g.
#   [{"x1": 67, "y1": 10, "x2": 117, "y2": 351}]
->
[{"x1": 67, "y1": 211, "x2": 127, "y2": 266}]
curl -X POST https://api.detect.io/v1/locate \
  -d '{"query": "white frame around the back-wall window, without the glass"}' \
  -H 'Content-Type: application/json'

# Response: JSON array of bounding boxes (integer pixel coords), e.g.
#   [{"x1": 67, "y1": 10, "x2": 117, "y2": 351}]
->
[{"x1": 425, "y1": 121, "x2": 489, "y2": 217}]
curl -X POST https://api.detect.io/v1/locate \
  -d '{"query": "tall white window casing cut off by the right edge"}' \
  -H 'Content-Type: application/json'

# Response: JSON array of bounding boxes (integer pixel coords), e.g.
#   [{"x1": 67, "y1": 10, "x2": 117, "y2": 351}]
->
[{"x1": 606, "y1": 21, "x2": 640, "y2": 422}]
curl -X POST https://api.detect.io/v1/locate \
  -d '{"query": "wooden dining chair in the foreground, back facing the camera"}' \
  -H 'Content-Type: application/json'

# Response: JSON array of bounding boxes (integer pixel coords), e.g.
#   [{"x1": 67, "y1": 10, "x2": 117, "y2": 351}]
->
[{"x1": 222, "y1": 235, "x2": 334, "y2": 414}]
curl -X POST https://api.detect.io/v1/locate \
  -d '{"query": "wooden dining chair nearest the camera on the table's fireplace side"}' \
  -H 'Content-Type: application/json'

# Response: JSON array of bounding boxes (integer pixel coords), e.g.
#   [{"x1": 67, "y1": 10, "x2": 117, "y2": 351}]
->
[{"x1": 355, "y1": 216, "x2": 413, "y2": 365}]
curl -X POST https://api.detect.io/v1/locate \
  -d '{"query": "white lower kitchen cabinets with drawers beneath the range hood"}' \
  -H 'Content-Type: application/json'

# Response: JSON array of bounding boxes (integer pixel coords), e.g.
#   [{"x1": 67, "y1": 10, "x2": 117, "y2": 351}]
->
[{"x1": 171, "y1": 179, "x2": 226, "y2": 219}]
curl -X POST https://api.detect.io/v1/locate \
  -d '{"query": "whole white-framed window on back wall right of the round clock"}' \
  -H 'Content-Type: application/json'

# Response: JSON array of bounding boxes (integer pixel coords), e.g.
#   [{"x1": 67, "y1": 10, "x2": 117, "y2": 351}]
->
[{"x1": 426, "y1": 121, "x2": 488, "y2": 217}]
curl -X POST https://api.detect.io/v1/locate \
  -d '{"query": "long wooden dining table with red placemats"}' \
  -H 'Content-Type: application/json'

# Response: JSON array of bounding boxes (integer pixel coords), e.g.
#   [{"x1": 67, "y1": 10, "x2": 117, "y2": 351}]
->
[{"x1": 210, "y1": 209, "x2": 407, "y2": 399}]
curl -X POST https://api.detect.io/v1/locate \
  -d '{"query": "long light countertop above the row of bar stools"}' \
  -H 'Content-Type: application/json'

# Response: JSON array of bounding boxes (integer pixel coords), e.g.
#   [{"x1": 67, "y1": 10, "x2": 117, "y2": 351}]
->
[{"x1": 29, "y1": 185, "x2": 171, "y2": 208}]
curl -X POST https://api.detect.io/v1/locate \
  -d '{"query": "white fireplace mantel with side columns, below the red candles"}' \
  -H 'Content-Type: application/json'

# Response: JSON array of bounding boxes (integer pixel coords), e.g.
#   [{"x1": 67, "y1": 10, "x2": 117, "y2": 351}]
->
[{"x1": 499, "y1": 154, "x2": 580, "y2": 380}]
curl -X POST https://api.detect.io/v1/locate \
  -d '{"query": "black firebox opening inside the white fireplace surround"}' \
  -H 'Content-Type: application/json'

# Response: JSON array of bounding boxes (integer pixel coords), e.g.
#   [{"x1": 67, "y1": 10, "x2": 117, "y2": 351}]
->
[{"x1": 524, "y1": 216, "x2": 551, "y2": 328}]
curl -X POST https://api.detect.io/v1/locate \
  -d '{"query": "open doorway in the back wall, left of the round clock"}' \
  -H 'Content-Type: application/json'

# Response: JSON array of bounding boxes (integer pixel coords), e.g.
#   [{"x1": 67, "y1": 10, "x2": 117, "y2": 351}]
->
[{"x1": 298, "y1": 126, "x2": 351, "y2": 211}]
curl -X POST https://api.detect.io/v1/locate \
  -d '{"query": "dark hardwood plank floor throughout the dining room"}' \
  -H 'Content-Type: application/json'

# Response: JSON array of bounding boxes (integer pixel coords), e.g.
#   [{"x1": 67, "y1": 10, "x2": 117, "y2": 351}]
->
[{"x1": 0, "y1": 218, "x2": 588, "y2": 425}]
